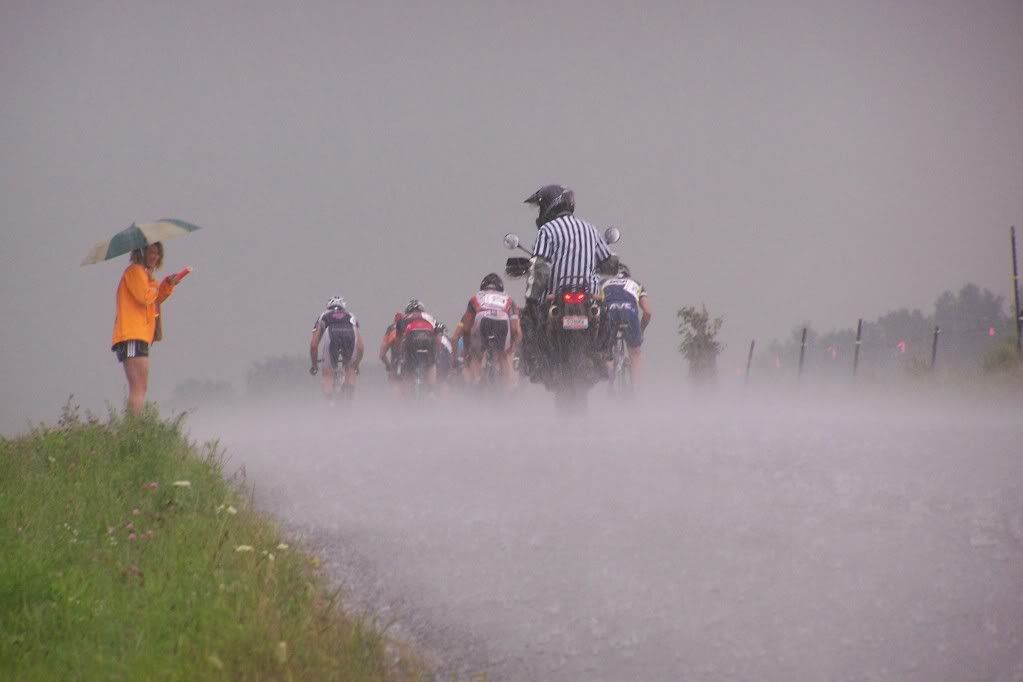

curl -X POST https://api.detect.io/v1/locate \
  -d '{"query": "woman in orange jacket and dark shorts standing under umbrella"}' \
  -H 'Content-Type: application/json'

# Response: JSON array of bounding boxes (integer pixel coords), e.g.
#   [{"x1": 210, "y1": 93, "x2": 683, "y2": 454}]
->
[{"x1": 110, "y1": 241, "x2": 181, "y2": 414}]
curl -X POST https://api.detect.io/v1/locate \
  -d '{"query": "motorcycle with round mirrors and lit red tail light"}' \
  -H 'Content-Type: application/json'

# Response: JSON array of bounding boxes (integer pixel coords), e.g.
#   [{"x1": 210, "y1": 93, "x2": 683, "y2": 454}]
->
[{"x1": 504, "y1": 227, "x2": 621, "y2": 412}]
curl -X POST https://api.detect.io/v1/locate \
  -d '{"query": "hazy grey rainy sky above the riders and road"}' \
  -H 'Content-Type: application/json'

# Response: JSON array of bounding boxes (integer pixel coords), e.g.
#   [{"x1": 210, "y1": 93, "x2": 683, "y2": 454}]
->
[{"x1": 0, "y1": 0, "x2": 1023, "y2": 429}]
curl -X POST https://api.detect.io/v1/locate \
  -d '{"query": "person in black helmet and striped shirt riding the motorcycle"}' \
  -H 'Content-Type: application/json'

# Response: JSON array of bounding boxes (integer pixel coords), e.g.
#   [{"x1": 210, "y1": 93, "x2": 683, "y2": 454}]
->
[{"x1": 523, "y1": 184, "x2": 618, "y2": 381}]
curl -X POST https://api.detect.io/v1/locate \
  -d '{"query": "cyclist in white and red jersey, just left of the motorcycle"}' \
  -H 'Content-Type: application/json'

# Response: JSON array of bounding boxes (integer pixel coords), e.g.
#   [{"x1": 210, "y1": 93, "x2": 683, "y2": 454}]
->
[{"x1": 453, "y1": 272, "x2": 522, "y2": 387}]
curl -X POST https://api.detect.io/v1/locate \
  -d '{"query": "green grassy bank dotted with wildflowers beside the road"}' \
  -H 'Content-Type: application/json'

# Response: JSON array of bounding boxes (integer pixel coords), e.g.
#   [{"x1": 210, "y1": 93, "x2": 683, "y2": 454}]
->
[{"x1": 0, "y1": 409, "x2": 420, "y2": 681}]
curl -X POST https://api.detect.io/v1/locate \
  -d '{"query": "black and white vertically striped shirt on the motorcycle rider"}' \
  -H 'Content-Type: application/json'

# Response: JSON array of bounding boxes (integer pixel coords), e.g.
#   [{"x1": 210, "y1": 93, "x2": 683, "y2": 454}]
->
[{"x1": 533, "y1": 216, "x2": 611, "y2": 293}]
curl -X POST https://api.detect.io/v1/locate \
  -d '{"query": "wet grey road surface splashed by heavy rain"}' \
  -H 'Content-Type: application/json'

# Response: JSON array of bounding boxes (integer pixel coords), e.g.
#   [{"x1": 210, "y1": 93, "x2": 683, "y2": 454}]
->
[{"x1": 190, "y1": 388, "x2": 1023, "y2": 682}]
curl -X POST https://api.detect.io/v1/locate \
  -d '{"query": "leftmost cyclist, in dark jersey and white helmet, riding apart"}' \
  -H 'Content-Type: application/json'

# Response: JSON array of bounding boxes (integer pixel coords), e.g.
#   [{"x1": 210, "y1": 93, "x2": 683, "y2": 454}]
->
[{"x1": 309, "y1": 295, "x2": 365, "y2": 401}]
